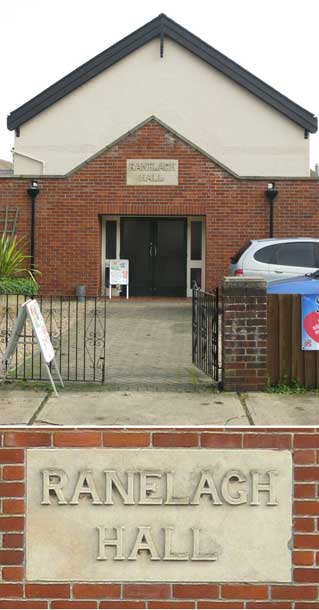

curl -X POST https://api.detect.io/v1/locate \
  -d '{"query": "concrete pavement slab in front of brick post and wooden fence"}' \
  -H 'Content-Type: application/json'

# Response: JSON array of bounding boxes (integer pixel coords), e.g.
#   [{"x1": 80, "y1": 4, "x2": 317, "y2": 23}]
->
[{"x1": 244, "y1": 392, "x2": 319, "y2": 426}]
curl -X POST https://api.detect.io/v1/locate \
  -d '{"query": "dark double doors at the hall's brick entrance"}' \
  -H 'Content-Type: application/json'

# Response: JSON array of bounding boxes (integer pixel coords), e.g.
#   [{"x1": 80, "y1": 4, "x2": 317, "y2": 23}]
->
[{"x1": 121, "y1": 218, "x2": 187, "y2": 297}]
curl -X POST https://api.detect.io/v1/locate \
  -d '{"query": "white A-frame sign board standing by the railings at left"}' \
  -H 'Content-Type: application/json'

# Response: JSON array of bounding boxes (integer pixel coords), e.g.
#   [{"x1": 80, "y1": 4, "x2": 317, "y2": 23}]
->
[{"x1": 4, "y1": 299, "x2": 64, "y2": 396}]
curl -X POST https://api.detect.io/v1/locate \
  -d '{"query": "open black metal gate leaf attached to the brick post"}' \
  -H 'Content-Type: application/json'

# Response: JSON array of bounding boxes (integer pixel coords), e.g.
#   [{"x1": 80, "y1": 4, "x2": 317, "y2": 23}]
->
[{"x1": 192, "y1": 287, "x2": 220, "y2": 381}]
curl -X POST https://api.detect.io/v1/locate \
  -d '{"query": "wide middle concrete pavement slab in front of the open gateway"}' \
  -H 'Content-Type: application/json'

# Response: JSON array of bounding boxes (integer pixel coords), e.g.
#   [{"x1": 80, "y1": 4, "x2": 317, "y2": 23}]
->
[{"x1": 33, "y1": 391, "x2": 249, "y2": 426}]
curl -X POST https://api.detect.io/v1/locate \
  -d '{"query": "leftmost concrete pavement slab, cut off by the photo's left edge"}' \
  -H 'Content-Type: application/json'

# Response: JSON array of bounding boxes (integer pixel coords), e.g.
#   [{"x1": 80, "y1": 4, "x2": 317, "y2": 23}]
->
[{"x1": 0, "y1": 388, "x2": 47, "y2": 425}]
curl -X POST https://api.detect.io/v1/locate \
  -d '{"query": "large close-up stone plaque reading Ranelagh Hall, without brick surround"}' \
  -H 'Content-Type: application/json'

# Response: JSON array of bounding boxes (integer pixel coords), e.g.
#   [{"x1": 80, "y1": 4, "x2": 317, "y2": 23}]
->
[{"x1": 26, "y1": 449, "x2": 292, "y2": 582}]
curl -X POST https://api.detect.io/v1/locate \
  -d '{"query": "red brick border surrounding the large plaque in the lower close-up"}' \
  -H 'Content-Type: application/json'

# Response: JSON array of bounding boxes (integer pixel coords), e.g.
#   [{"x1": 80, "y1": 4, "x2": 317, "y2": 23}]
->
[{"x1": 0, "y1": 428, "x2": 319, "y2": 609}]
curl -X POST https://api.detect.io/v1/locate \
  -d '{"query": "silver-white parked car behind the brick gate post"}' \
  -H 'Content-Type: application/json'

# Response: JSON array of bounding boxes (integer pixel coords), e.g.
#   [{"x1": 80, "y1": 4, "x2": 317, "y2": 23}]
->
[{"x1": 229, "y1": 237, "x2": 319, "y2": 281}]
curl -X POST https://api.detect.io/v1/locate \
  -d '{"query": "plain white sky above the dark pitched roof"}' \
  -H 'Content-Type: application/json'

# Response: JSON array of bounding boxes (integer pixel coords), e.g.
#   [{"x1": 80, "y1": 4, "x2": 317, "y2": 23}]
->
[{"x1": 0, "y1": 0, "x2": 319, "y2": 167}]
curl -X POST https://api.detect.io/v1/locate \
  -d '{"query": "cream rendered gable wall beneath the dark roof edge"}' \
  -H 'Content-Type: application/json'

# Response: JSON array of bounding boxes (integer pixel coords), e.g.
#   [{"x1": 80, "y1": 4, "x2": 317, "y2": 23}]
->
[{"x1": 14, "y1": 39, "x2": 309, "y2": 176}]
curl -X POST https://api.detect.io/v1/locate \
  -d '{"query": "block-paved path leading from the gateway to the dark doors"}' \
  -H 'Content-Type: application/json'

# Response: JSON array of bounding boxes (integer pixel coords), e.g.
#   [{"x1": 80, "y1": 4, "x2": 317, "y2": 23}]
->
[{"x1": 105, "y1": 299, "x2": 212, "y2": 391}]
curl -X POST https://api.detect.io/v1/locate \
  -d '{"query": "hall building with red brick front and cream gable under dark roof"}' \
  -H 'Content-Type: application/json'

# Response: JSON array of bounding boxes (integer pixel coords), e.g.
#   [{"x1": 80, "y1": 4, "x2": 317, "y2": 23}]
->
[{"x1": 0, "y1": 15, "x2": 319, "y2": 296}]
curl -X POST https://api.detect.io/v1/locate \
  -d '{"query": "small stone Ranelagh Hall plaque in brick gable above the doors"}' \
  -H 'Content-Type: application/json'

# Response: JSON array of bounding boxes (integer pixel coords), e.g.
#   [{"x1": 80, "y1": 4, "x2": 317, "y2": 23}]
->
[{"x1": 126, "y1": 159, "x2": 178, "y2": 186}]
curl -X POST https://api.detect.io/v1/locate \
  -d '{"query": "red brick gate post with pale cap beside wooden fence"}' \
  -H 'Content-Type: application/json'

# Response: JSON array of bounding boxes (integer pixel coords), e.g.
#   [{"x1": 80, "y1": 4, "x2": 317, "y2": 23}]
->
[{"x1": 222, "y1": 277, "x2": 268, "y2": 392}]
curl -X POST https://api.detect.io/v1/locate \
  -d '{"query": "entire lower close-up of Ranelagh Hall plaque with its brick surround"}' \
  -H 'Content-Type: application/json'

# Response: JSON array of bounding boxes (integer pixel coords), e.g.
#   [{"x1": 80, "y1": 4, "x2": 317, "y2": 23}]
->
[{"x1": 0, "y1": 427, "x2": 319, "y2": 610}]
